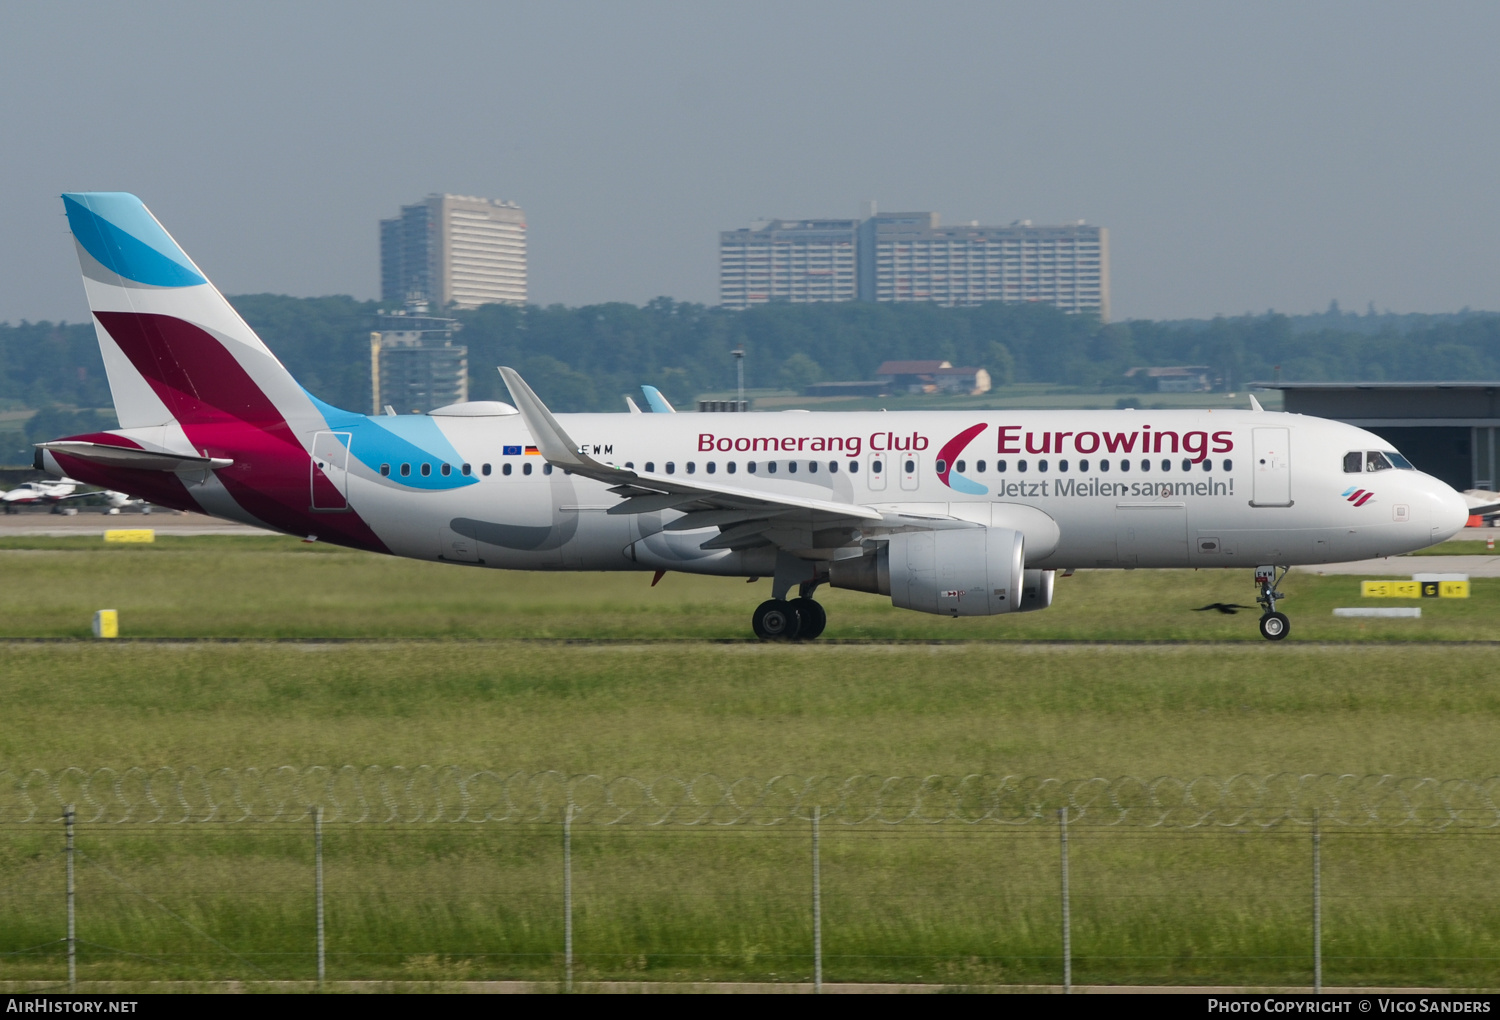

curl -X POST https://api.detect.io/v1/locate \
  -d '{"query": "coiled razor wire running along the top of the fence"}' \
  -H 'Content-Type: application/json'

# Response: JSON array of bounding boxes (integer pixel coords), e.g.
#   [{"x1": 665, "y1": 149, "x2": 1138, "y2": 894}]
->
[{"x1": 0, "y1": 765, "x2": 1500, "y2": 831}]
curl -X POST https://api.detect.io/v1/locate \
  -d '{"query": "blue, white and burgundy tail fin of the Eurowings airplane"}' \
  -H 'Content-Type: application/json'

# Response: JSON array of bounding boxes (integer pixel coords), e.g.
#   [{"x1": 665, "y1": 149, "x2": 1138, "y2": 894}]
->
[{"x1": 63, "y1": 192, "x2": 326, "y2": 438}]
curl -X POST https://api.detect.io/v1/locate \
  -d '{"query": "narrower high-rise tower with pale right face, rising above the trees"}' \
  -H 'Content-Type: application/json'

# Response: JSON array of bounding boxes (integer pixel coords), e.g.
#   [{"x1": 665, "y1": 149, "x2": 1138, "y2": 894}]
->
[{"x1": 380, "y1": 195, "x2": 527, "y2": 308}]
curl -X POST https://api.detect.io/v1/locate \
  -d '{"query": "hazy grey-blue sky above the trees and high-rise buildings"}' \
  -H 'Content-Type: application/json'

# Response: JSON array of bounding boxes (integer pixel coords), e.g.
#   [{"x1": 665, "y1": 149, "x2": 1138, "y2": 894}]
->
[{"x1": 0, "y1": 0, "x2": 1500, "y2": 321}]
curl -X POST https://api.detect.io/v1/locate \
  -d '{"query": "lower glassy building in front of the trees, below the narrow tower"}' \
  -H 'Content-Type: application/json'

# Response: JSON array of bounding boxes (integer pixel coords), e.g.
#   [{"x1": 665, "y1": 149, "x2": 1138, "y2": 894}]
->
[{"x1": 371, "y1": 303, "x2": 468, "y2": 414}]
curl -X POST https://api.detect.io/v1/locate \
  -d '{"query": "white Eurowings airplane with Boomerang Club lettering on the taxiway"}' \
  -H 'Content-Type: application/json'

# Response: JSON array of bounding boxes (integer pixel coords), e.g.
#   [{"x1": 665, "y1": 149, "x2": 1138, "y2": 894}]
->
[{"x1": 36, "y1": 192, "x2": 1469, "y2": 641}]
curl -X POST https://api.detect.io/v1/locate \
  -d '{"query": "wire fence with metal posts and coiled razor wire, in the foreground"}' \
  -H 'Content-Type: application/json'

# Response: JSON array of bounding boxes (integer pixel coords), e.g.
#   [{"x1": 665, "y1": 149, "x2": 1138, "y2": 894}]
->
[{"x1": 0, "y1": 765, "x2": 1500, "y2": 989}]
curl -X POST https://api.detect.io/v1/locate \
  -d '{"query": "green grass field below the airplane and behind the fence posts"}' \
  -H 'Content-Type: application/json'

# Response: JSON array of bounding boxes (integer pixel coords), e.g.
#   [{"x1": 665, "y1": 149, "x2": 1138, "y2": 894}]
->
[{"x1": 0, "y1": 539, "x2": 1500, "y2": 987}]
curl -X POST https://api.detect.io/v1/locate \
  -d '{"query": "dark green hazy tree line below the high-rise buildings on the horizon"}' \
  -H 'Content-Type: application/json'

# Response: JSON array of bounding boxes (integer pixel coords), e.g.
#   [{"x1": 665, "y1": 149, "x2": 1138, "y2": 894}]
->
[{"x1": 0, "y1": 294, "x2": 1500, "y2": 461}]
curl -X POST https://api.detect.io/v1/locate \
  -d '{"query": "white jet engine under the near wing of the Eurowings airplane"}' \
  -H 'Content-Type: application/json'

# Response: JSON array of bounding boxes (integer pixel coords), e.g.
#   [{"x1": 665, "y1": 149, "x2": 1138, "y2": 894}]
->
[{"x1": 828, "y1": 528, "x2": 1026, "y2": 617}]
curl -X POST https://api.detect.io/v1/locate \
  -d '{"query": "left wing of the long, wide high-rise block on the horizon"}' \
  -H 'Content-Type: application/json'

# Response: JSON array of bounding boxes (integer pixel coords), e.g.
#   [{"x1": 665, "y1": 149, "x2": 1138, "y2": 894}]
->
[{"x1": 719, "y1": 219, "x2": 860, "y2": 309}]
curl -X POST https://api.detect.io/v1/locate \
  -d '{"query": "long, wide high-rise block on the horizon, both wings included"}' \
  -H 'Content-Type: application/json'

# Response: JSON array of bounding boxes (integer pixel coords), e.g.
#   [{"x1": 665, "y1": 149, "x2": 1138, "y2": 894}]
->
[{"x1": 719, "y1": 209, "x2": 1110, "y2": 320}]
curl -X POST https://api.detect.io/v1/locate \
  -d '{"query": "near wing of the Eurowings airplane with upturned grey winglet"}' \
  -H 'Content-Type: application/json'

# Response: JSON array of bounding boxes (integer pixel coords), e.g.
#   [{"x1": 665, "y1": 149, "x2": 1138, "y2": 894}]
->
[{"x1": 500, "y1": 368, "x2": 882, "y2": 558}]
